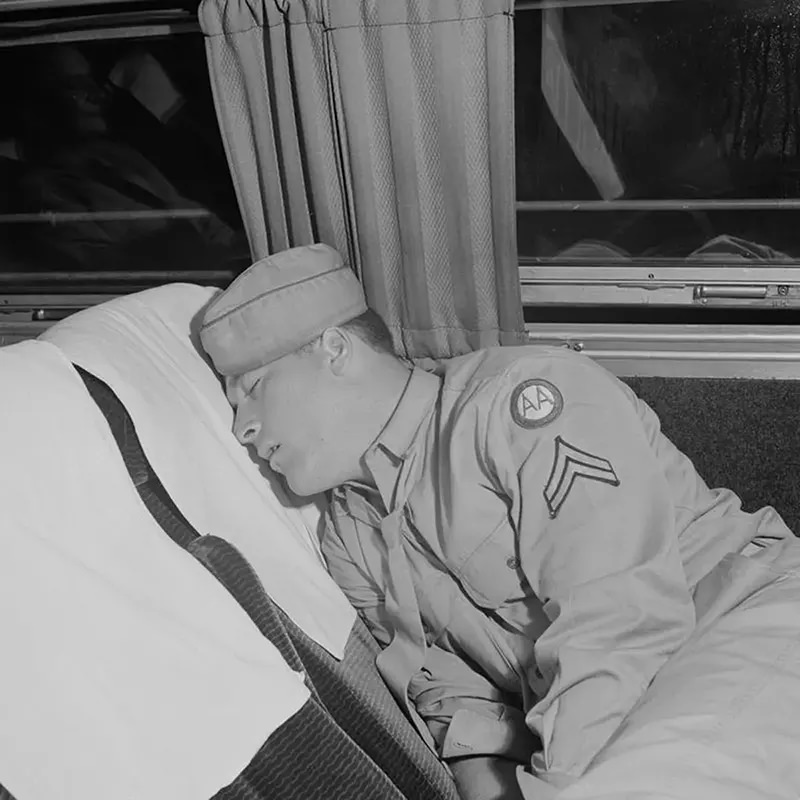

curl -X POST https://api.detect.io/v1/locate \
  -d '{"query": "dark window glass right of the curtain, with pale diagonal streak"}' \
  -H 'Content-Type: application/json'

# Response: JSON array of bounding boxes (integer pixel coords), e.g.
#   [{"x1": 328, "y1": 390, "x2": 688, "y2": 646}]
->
[{"x1": 515, "y1": 0, "x2": 800, "y2": 266}]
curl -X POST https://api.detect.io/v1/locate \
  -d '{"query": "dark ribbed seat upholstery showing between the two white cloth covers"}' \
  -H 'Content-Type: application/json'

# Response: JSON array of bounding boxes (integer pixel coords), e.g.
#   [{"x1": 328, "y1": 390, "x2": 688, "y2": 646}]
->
[{"x1": 71, "y1": 369, "x2": 458, "y2": 800}]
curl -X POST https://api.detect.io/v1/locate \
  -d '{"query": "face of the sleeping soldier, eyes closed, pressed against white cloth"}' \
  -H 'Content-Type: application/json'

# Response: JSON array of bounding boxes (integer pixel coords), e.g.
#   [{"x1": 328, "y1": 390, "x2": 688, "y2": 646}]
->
[{"x1": 226, "y1": 352, "x2": 350, "y2": 497}]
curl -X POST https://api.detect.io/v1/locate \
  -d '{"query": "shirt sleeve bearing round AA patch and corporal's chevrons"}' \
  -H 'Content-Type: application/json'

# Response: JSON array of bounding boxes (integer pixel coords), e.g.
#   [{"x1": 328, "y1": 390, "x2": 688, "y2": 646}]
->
[{"x1": 478, "y1": 356, "x2": 695, "y2": 784}]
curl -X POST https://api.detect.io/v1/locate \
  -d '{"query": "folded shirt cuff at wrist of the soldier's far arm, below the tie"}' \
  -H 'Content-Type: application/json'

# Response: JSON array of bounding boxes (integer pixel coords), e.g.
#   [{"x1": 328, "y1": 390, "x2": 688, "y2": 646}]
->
[{"x1": 442, "y1": 706, "x2": 540, "y2": 764}]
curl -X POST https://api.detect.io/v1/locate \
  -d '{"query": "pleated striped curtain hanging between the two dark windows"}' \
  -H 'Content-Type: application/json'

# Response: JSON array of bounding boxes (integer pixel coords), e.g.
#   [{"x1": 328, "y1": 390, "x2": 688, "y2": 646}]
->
[{"x1": 200, "y1": 0, "x2": 524, "y2": 358}]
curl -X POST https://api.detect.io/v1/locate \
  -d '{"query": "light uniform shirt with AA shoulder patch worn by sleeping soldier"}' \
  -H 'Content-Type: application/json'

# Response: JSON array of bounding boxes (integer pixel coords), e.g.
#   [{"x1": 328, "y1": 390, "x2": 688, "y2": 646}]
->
[{"x1": 322, "y1": 347, "x2": 792, "y2": 784}]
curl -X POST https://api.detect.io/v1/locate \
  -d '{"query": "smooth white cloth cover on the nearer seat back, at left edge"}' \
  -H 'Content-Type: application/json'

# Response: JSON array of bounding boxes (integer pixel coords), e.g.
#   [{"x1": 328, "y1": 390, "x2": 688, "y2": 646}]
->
[{"x1": 0, "y1": 341, "x2": 308, "y2": 800}]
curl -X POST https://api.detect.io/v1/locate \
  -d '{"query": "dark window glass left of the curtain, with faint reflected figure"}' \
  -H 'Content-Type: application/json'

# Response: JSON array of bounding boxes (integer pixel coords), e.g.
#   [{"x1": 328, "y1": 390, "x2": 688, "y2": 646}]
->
[{"x1": 0, "y1": 23, "x2": 249, "y2": 285}]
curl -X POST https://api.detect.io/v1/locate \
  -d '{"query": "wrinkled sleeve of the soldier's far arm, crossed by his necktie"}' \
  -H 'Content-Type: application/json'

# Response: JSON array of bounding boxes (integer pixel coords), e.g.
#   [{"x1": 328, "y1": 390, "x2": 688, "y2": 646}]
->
[{"x1": 322, "y1": 500, "x2": 538, "y2": 763}]
